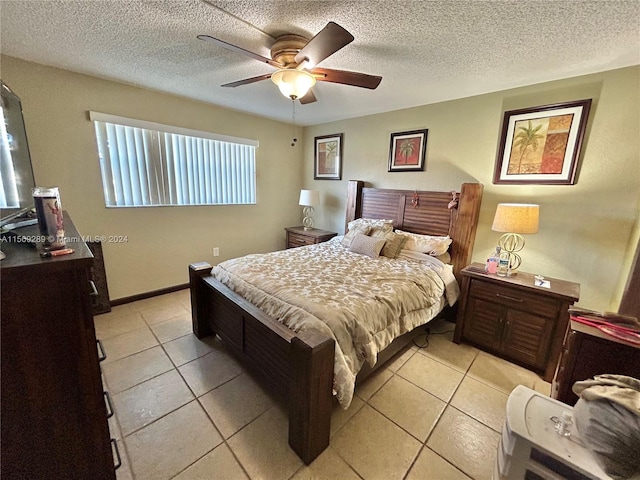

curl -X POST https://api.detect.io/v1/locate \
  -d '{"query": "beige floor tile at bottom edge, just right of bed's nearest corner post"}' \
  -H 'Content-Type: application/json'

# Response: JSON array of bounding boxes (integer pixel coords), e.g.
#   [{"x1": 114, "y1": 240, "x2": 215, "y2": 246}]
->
[{"x1": 331, "y1": 405, "x2": 421, "y2": 480}]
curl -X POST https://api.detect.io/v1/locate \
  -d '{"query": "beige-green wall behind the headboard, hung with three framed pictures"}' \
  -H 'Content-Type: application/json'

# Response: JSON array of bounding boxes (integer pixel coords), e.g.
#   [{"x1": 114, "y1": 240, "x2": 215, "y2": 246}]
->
[{"x1": 303, "y1": 67, "x2": 640, "y2": 310}]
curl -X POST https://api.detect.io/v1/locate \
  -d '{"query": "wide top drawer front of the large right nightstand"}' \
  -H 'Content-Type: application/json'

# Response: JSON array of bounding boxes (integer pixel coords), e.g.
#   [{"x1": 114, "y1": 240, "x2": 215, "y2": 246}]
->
[{"x1": 469, "y1": 279, "x2": 560, "y2": 318}]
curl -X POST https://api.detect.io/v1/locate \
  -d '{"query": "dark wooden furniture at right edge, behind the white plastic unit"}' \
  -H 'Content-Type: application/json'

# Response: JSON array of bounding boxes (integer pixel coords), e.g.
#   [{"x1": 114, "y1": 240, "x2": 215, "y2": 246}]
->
[{"x1": 551, "y1": 320, "x2": 640, "y2": 405}]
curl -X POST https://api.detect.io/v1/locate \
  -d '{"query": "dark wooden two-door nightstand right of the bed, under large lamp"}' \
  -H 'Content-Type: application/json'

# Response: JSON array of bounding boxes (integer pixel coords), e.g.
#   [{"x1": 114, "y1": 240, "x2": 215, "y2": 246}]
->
[{"x1": 453, "y1": 263, "x2": 580, "y2": 382}]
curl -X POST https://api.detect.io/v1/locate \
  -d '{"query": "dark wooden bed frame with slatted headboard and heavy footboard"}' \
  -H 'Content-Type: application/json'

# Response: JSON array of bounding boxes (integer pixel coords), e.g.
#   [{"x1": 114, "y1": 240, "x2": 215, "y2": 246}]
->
[{"x1": 189, "y1": 181, "x2": 482, "y2": 464}]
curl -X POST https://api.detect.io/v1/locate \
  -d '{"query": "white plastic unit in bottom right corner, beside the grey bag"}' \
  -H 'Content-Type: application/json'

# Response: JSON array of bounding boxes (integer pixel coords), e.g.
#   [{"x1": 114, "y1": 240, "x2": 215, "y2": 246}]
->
[{"x1": 493, "y1": 385, "x2": 611, "y2": 480}]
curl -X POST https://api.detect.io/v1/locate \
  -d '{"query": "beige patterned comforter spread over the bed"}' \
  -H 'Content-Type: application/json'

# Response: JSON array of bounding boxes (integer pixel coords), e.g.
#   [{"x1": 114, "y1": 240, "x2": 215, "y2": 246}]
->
[{"x1": 212, "y1": 237, "x2": 457, "y2": 408}]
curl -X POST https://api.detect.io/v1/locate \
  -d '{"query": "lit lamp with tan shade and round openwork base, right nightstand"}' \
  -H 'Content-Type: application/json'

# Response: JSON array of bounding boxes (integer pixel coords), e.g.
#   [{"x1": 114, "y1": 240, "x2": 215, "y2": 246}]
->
[{"x1": 491, "y1": 203, "x2": 540, "y2": 276}]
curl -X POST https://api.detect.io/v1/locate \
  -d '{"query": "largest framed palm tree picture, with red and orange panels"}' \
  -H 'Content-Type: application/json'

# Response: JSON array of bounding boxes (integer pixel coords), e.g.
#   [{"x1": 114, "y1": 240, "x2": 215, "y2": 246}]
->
[{"x1": 493, "y1": 99, "x2": 591, "y2": 185}]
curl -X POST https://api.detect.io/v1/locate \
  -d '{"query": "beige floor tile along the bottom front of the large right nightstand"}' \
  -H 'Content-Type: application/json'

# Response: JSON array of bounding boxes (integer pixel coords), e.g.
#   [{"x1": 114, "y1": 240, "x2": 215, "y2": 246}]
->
[{"x1": 467, "y1": 352, "x2": 539, "y2": 394}]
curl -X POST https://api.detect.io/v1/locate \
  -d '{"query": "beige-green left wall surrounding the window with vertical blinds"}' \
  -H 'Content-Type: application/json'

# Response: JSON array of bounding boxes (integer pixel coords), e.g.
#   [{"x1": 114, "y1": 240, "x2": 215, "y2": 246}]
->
[{"x1": 1, "y1": 56, "x2": 302, "y2": 299}]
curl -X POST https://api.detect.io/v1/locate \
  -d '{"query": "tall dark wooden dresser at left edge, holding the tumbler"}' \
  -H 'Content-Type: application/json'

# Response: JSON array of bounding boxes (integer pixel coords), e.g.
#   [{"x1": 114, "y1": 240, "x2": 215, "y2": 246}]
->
[{"x1": 0, "y1": 215, "x2": 119, "y2": 480}]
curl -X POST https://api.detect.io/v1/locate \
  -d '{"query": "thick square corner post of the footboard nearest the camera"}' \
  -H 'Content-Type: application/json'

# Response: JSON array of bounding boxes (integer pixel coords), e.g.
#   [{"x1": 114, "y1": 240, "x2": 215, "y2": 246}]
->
[{"x1": 289, "y1": 332, "x2": 335, "y2": 465}]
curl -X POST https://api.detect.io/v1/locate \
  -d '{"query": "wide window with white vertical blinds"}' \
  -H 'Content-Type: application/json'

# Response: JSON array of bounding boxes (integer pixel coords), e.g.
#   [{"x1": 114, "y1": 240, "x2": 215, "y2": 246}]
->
[{"x1": 90, "y1": 112, "x2": 258, "y2": 207}]
